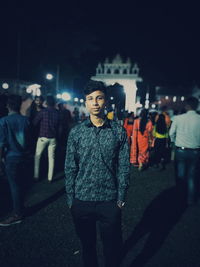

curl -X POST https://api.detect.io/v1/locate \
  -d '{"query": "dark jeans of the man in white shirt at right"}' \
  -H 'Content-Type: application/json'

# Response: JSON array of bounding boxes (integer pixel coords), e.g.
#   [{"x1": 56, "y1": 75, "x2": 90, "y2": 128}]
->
[{"x1": 175, "y1": 148, "x2": 200, "y2": 204}]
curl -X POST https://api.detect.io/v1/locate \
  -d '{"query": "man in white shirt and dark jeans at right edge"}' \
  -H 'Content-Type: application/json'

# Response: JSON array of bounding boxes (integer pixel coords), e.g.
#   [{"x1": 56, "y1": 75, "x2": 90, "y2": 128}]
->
[{"x1": 169, "y1": 97, "x2": 200, "y2": 205}]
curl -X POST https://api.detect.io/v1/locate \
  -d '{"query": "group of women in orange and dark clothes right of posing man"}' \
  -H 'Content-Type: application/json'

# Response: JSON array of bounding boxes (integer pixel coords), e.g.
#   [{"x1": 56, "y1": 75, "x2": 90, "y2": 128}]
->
[{"x1": 123, "y1": 108, "x2": 171, "y2": 171}]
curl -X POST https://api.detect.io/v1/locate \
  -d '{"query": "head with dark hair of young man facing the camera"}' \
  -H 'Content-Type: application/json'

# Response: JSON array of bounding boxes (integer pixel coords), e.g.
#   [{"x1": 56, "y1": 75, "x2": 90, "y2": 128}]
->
[{"x1": 84, "y1": 80, "x2": 107, "y2": 116}]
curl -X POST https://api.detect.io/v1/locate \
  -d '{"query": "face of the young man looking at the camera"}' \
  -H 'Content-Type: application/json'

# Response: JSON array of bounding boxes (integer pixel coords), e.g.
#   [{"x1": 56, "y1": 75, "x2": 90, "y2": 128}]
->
[{"x1": 85, "y1": 91, "x2": 106, "y2": 116}]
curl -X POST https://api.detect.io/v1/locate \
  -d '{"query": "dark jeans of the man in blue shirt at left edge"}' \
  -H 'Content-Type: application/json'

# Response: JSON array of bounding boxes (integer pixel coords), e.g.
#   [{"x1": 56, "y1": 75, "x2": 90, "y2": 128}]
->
[{"x1": 5, "y1": 157, "x2": 31, "y2": 215}]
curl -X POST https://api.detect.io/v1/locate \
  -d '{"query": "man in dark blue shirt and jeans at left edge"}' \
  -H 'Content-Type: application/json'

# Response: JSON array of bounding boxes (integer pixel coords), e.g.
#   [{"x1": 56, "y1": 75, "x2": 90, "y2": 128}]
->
[{"x1": 0, "y1": 95, "x2": 30, "y2": 226}]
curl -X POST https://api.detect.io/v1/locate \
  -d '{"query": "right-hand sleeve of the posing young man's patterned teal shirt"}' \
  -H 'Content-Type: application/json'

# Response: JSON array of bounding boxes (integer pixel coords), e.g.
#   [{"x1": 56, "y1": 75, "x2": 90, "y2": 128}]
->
[{"x1": 117, "y1": 129, "x2": 130, "y2": 202}]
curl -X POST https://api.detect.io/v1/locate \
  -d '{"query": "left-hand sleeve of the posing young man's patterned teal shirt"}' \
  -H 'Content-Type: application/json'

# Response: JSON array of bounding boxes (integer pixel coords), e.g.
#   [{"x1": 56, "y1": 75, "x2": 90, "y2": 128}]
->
[{"x1": 65, "y1": 129, "x2": 78, "y2": 208}]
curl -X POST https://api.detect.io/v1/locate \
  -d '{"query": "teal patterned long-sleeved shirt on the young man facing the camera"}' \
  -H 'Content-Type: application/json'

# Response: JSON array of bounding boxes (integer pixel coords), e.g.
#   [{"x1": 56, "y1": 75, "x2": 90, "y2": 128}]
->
[{"x1": 65, "y1": 119, "x2": 130, "y2": 207}]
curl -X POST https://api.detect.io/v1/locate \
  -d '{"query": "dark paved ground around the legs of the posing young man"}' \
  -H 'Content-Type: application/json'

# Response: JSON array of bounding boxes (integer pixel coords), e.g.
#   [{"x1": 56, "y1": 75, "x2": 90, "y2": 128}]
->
[{"x1": 0, "y1": 164, "x2": 200, "y2": 267}]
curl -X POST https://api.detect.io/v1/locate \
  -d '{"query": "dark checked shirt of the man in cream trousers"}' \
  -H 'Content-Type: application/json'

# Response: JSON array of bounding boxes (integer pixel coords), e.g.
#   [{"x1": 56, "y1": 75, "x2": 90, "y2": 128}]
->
[{"x1": 33, "y1": 107, "x2": 59, "y2": 138}]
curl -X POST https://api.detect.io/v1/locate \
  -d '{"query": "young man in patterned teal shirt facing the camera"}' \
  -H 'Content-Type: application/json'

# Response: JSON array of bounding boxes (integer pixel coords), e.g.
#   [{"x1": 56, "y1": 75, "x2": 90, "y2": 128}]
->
[{"x1": 65, "y1": 81, "x2": 130, "y2": 267}]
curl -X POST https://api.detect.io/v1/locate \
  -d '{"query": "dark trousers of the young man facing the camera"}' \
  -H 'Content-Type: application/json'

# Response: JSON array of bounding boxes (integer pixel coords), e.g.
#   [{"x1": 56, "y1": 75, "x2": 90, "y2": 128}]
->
[{"x1": 71, "y1": 199, "x2": 122, "y2": 267}]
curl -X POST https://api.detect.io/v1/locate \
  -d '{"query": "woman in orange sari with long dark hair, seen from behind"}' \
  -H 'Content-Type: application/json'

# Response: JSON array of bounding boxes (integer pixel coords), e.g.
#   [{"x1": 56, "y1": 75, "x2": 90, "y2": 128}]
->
[{"x1": 130, "y1": 109, "x2": 153, "y2": 171}]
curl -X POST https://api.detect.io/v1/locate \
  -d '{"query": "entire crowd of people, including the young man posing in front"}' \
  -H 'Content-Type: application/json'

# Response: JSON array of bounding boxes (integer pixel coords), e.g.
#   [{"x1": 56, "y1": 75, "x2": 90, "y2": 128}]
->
[{"x1": 0, "y1": 80, "x2": 200, "y2": 267}]
